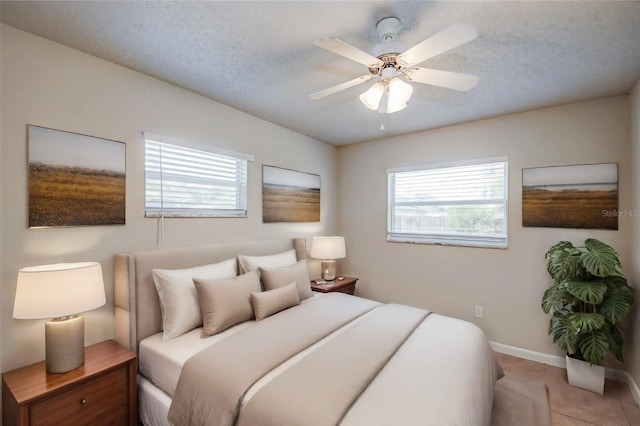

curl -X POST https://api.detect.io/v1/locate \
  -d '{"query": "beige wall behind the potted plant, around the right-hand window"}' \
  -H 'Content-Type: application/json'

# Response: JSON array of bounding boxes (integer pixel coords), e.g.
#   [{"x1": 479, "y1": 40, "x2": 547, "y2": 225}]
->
[{"x1": 338, "y1": 96, "x2": 638, "y2": 362}]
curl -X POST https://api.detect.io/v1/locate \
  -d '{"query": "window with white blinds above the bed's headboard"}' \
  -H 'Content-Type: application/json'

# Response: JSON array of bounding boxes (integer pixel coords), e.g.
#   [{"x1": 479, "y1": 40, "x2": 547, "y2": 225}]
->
[{"x1": 144, "y1": 132, "x2": 253, "y2": 217}]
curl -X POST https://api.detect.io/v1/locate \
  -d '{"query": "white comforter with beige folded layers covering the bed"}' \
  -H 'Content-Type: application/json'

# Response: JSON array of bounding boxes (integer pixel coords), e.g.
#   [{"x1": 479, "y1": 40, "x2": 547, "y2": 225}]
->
[{"x1": 162, "y1": 293, "x2": 502, "y2": 426}]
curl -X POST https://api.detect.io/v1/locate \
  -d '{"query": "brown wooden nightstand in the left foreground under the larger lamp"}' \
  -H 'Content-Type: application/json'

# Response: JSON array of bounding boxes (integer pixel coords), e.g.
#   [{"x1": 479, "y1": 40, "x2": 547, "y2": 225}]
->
[{"x1": 2, "y1": 340, "x2": 138, "y2": 426}]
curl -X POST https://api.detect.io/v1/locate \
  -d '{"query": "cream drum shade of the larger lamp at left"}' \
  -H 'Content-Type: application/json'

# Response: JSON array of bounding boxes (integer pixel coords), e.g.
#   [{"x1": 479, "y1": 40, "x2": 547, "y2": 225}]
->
[{"x1": 13, "y1": 262, "x2": 106, "y2": 319}]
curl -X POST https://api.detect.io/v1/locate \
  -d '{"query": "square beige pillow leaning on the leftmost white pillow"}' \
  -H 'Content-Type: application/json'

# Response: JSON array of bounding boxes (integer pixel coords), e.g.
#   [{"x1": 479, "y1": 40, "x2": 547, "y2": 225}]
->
[{"x1": 193, "y1": 271, "x2": 262, "y2": 337}]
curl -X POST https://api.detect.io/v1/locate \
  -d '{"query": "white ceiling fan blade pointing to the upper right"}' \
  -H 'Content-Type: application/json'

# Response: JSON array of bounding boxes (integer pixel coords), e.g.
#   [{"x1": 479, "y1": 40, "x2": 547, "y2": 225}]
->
[{"x1": 398, "y1": 22, "x2": 478, "y2": 66}]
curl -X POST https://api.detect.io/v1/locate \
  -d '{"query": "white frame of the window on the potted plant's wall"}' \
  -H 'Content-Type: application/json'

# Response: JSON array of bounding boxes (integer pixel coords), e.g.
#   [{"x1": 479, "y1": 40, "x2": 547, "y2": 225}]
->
[{"x1": 386, "y1": 156, "x2": 509, "y2": 249}]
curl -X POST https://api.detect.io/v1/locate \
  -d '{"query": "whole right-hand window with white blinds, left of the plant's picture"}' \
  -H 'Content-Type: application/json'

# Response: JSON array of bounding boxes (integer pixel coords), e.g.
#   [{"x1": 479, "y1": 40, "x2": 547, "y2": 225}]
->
[{"x1": 387, "y1": 158, "x2": 507, "y2": 248}]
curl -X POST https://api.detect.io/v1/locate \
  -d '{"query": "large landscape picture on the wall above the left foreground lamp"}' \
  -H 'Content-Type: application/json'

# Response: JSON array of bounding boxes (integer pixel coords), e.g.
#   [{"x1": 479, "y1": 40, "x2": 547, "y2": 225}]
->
[{"x1": 28, "y1": 126, "x2": 126, "y2": 228}]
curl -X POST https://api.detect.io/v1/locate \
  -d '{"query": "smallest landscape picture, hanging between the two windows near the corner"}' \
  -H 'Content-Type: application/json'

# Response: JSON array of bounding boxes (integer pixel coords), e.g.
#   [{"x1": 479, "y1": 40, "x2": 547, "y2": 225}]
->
[{"x1": 262, "y1": 165, "x2": 320, "y2": 223}]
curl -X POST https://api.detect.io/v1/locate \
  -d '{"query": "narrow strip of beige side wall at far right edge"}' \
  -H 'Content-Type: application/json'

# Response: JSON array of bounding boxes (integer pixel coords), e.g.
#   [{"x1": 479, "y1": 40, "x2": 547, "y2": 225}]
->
[{"x1": 625, "y1": 81, "x2": 640, "y2": 386}]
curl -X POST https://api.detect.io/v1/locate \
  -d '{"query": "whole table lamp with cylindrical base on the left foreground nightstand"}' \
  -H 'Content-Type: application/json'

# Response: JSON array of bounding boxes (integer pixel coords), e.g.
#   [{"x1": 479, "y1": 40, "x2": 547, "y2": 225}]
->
[{"x1": 13, "y1": 262, "x2": 106, "y2": 373}]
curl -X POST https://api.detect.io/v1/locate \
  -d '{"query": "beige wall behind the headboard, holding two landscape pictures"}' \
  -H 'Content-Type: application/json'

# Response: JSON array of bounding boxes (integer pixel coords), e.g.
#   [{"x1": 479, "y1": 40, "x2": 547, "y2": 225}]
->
[{"x1": 0, "y1": 25, "x2": 337, "y2": 371}]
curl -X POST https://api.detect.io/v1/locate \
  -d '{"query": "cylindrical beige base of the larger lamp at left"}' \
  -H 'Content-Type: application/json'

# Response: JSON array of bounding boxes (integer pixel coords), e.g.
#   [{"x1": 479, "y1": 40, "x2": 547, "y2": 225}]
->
[{"x1": 44, "y1": 315, "x2": 84, "y2": 373}]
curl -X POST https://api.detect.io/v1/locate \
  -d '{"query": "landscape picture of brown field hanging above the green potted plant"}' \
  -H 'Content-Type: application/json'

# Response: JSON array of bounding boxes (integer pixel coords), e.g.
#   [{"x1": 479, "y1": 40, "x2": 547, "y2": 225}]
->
[{"x1": 522, "y1": 163, "x2": 618, "y2": 230}]
